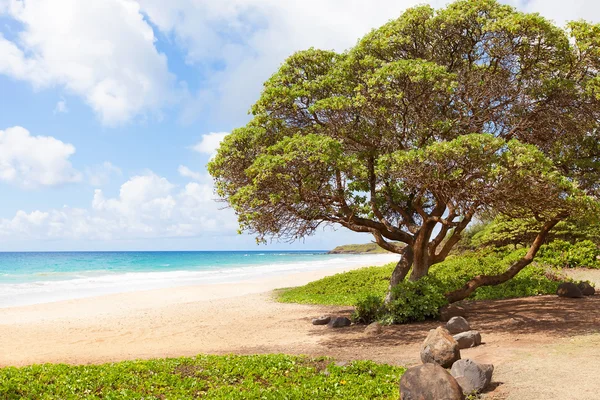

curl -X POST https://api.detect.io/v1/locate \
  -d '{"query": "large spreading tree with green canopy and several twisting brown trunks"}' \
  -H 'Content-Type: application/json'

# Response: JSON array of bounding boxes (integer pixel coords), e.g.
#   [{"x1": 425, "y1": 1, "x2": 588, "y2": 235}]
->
[{"x1": 209, "y1": 0, "x2": 600, "y2": 301}]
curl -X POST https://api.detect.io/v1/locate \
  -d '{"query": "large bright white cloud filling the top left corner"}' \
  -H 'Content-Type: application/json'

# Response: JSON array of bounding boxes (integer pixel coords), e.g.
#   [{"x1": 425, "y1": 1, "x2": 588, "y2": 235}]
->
[{"x1": 0, "y1": 0, "x2": 174, "y2": 125}]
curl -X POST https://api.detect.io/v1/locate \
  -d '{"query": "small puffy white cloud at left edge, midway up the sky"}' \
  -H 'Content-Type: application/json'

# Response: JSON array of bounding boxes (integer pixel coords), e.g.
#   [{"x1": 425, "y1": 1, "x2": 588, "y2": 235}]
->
[{"x1": 0, "y1": 126, "x2": 81, "y2": 188}]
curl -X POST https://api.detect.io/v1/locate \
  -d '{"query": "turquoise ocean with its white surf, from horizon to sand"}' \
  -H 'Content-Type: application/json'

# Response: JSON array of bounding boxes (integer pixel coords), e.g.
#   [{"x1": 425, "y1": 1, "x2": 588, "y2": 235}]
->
[{"x1": 0, "y1": 251, "x2": 396, "y2": 308}]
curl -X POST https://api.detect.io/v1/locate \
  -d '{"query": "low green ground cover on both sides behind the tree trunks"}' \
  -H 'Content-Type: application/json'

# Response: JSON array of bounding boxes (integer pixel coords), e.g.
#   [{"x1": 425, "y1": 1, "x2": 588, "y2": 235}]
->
[{"x1": 277, "y1": 249, "x2": 560, "y2": 306}]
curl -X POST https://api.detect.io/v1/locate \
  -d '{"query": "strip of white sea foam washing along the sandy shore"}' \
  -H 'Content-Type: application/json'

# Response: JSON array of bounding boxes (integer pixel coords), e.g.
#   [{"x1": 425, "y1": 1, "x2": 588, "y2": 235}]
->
[{"x1": 0, "y1": 254, "x2": 398, "y2": 308}]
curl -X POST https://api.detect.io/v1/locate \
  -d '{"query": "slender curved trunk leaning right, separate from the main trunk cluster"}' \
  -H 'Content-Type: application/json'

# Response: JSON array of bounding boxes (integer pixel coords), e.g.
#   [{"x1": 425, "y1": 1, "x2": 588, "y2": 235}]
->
[{"x1": 446, "y1": 219, "x2": 560, "y2": 303}]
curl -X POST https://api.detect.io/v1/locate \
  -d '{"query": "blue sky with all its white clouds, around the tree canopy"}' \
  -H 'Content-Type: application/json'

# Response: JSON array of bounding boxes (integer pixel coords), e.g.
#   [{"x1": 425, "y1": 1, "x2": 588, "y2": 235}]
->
[{"x1": 0, "y1": 0, "x2": 600, "y2": 251}]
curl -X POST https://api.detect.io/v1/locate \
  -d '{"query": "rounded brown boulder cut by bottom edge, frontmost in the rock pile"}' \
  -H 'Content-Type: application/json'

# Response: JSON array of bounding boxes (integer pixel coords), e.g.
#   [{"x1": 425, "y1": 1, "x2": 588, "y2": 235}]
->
[{"x1": 400, "y1": 364, "x2": 464, "y2": 400}]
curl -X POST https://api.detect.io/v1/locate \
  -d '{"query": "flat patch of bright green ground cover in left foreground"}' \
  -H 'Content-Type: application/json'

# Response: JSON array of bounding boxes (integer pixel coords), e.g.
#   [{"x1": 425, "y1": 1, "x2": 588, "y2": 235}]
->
[{"x1": 0, "y1": 355, "x2": 405, "y2": 400}]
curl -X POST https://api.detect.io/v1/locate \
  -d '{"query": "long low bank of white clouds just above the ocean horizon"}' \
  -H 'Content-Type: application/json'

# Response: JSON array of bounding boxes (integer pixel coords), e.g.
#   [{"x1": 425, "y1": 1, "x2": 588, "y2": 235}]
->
[{"x1": 0, "y1": 172, "x2": 237, "y2": 240}]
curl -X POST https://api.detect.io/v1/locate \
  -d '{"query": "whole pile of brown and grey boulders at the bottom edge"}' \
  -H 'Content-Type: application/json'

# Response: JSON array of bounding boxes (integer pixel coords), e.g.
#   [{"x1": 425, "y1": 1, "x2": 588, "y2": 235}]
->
[{"x1": 400, "y1": 316, "x2": 494, "y2": 400}]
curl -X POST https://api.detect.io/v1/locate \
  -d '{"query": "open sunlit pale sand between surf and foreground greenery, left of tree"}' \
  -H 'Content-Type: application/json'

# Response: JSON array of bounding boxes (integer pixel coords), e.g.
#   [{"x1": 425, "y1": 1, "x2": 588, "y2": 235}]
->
[{"x1": 0, "y1": 257, "x2": 398, "y2": 367}]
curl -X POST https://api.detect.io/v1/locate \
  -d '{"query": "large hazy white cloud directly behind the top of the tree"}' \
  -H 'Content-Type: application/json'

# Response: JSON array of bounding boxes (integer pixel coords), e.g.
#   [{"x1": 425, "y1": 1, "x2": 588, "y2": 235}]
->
[{"x1": 139, "y1": 0, "x2": 600, "y2": 125}]
